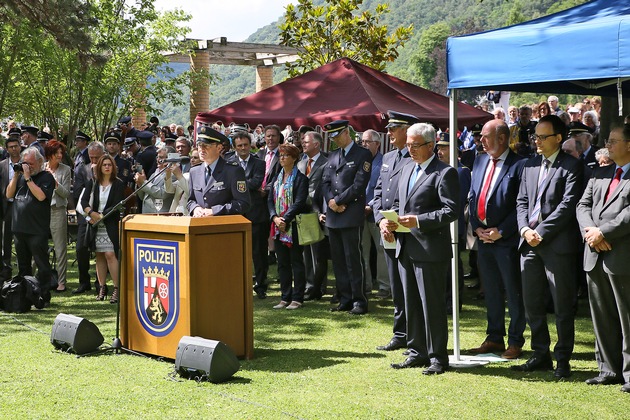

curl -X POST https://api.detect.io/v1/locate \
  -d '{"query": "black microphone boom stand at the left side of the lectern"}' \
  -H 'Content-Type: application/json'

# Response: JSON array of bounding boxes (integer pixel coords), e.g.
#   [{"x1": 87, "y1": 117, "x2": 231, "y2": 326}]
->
[{"x1": 77, "y1": 162, "x2": 179, "y2": 357}]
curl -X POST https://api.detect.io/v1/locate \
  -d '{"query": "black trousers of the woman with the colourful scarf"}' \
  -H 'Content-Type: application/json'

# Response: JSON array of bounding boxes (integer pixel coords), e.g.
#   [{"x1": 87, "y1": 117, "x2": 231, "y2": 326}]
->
[{"x1": 274, "y1": 238, "x2": 306, "y2": 303}]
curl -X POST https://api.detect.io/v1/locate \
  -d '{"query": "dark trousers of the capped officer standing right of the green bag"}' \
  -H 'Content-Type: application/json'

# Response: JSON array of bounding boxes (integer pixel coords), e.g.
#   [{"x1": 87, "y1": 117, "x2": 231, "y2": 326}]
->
[{"x1": 328, "y1": 226, "x2": 367, "y2": 309}]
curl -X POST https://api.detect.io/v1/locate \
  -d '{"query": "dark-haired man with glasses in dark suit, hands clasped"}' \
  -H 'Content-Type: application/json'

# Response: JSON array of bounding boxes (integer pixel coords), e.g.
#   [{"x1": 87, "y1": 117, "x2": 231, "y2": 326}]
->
[{"x1": 512, "y1": 115, "x2": 583, "y2": 378}]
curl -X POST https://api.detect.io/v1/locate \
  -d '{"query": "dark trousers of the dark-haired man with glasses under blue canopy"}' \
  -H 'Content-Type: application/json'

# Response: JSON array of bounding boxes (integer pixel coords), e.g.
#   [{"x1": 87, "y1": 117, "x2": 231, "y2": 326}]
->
[{"x1": 521, "y1": 248, "x2": 577, "y2": 362}]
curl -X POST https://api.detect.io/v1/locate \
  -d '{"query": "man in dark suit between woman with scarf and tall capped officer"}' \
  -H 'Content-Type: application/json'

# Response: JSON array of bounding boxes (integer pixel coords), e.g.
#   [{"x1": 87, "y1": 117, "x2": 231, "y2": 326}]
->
[{"x1": 297, "y1": 131, "x2": 330, "y2": 300}]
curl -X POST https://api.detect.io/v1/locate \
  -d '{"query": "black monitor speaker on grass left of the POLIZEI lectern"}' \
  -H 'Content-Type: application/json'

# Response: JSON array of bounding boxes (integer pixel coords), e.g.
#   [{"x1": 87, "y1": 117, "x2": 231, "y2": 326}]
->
[{"x1": 50, "y1": 314, "x2": 104, "y2": 354}]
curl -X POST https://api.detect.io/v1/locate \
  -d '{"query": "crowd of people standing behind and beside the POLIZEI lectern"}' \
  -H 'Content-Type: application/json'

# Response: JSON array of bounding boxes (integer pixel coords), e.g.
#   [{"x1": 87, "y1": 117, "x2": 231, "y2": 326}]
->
[{"x1": 0, "y1": 96, "x2": 630, "y2": 392}]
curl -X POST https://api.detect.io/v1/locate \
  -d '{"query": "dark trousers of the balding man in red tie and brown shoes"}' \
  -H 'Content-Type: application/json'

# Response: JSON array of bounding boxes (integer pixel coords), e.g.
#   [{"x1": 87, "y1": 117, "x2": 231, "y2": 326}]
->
[{"x1": 477, "y1": 241, "x2": 525, "y2": 347}]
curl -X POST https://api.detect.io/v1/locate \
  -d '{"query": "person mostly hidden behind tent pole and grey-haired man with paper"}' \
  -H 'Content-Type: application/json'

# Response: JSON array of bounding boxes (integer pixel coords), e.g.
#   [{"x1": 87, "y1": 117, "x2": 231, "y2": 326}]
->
[{"x1": 437, "y1": 132, "x2": 471, "y2": 312}]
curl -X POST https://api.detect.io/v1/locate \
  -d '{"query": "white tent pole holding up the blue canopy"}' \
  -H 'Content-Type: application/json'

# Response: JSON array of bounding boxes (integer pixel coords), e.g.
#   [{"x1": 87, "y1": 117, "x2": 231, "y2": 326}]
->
[{"x1": 448, "y1": 89, "x2": 463, "y2": 361}]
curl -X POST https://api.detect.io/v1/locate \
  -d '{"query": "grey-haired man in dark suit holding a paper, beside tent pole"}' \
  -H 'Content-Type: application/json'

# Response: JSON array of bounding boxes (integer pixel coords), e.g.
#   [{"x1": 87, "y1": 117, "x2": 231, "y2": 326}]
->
[{"x1": 392, "y1": 123, "x2": 459, "y2": 375}]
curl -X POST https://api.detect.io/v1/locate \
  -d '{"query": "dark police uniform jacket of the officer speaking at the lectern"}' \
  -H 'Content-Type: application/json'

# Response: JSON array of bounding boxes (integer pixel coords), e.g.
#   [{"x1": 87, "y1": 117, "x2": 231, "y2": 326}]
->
[{"x1": 186, "y1": 157, "x2": 251, "y2": 216}]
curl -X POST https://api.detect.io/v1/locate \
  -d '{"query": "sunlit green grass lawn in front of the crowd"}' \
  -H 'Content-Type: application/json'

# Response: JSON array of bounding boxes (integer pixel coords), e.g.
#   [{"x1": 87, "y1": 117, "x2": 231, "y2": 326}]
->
[{"x1": 0, "y1": 254, "x2": 630, "y2": 419}]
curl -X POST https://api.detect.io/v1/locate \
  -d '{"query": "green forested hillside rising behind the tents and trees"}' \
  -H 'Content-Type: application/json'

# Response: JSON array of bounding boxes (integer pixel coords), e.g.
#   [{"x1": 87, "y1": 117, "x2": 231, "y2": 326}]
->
[{"x1": 157, "y1": 0, "x2": 586, "y2": 122}]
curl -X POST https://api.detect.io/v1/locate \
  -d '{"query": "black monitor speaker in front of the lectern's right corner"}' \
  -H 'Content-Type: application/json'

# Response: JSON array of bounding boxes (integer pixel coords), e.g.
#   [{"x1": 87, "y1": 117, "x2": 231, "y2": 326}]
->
[{"x1": 175, "y1": 336, "x2": 241, "y2": 383}]
